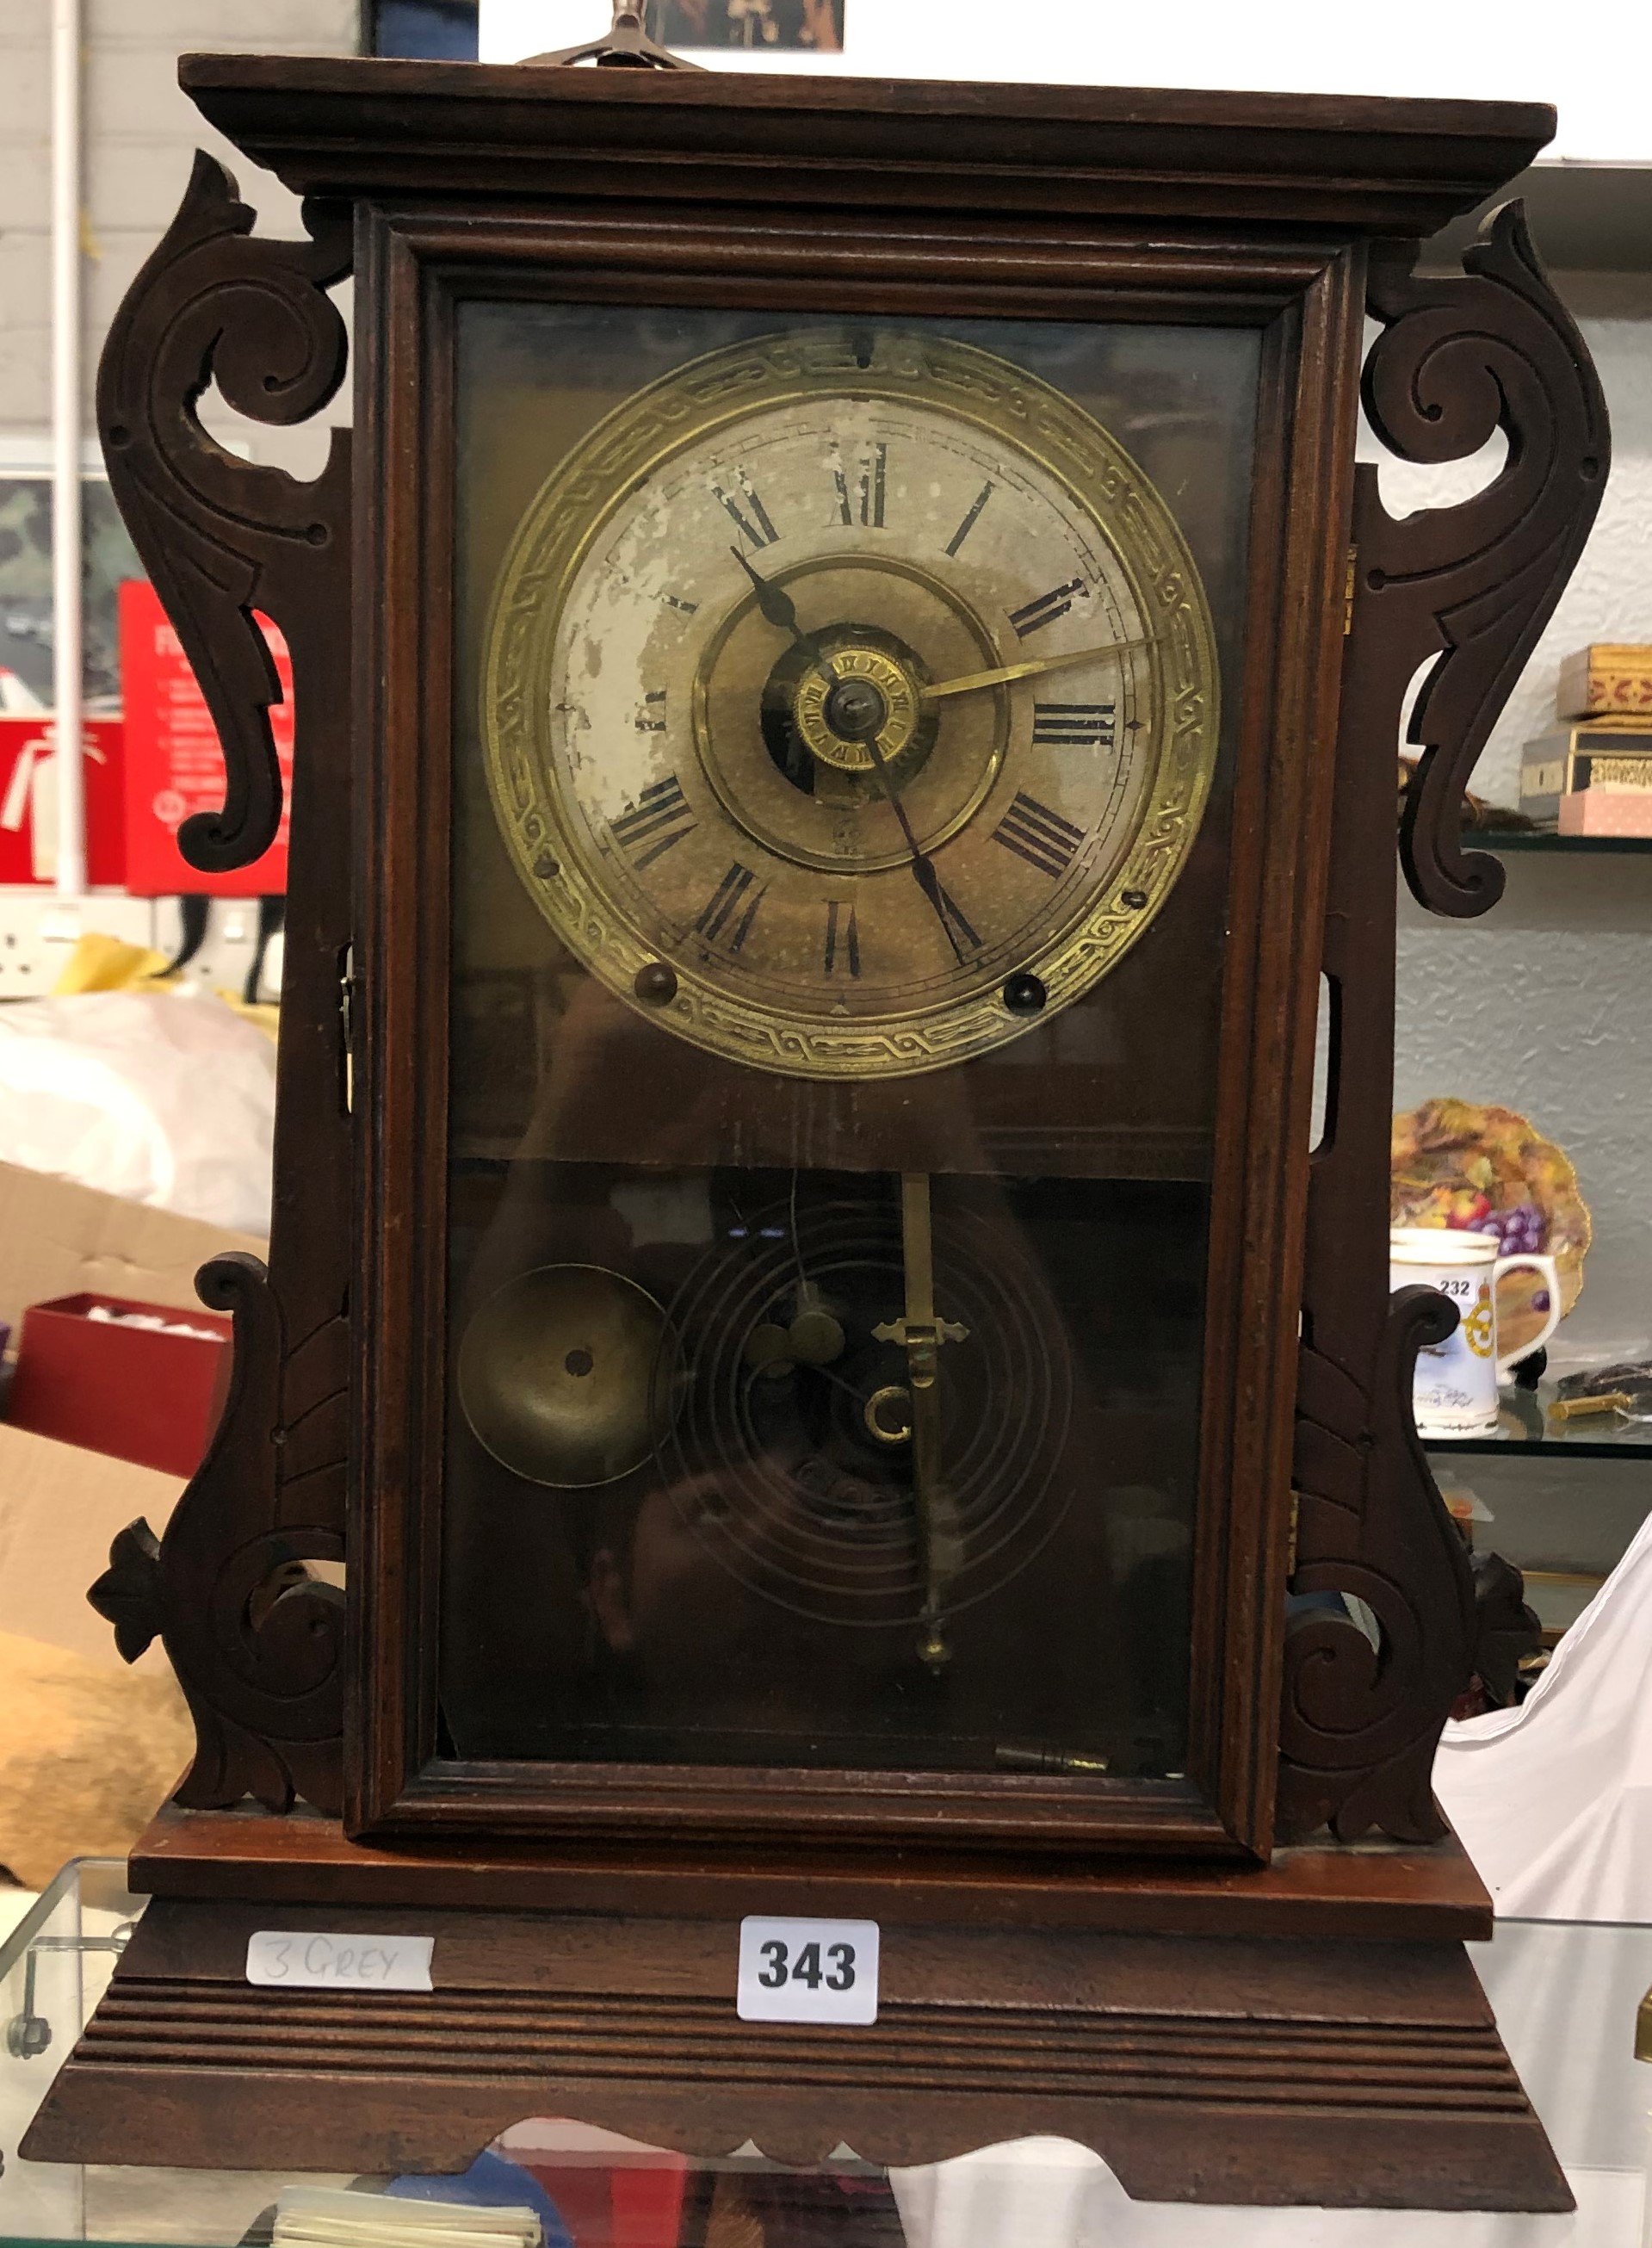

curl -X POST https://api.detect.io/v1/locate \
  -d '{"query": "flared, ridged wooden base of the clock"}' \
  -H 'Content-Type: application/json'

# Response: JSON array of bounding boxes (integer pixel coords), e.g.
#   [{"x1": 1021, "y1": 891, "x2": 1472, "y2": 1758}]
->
[{"x1": 22, "y1": 1814, "x2": 1571, "y2": 2210}]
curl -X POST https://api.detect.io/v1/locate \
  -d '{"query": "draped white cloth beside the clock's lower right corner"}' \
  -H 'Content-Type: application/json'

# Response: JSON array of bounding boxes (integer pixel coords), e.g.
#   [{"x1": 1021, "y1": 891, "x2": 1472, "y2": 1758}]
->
[{"x1": 1434, "y1": 1517, "x2": 1652, "y2": 1920}]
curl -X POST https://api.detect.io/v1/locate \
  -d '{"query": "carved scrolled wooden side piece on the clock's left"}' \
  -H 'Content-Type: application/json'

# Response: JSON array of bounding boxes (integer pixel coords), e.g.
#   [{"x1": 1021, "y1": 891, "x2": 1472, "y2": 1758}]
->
[{"x1": 92, "y1": 155, "x2": 350, "y2": 1810}]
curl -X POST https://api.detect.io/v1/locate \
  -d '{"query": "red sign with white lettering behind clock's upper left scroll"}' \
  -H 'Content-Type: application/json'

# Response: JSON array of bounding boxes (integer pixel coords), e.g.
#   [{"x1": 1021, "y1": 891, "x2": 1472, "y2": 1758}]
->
[{"x1": 119, "y1": 578, "x2": 292, "y2": 897}]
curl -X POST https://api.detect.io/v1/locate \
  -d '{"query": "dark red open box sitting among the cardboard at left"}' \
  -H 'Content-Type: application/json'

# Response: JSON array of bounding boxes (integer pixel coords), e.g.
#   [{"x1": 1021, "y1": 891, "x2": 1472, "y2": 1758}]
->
[{"x1": 7, "y1": 1295, "x2": 234, "y2": 1475}]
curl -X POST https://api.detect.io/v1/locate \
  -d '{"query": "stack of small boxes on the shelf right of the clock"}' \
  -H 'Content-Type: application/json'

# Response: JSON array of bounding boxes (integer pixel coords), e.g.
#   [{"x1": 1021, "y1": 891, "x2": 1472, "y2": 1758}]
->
[{"x1": 1519, "y1": 645, "x2": 1652, "y2": 836}]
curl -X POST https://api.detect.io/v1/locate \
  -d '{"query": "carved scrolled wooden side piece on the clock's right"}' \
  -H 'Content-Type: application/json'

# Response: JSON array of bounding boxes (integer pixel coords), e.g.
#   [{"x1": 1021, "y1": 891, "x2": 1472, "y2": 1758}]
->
[{"x1": 1279, "y1": 202, "x2": 1609, "y2": 1841}]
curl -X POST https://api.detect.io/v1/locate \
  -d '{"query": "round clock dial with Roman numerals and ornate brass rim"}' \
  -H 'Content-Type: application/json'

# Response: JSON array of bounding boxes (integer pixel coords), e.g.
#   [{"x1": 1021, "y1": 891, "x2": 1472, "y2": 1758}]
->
[{"x1": 483, "y1": 332, "x2": 1218, "y2": 1077}]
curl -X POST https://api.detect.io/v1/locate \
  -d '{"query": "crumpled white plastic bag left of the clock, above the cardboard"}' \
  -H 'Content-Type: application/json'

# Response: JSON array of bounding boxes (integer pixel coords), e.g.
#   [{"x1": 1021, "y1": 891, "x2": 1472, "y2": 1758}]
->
[{"x1": 0, "y1": 991, "x2": 275, "y2": 1234}]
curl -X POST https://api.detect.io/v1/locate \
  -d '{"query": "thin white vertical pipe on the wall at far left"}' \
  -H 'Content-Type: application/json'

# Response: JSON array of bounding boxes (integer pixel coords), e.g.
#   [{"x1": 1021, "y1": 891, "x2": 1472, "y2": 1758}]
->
[{"x1": 52, "y1": 0, "x2": 85, "y2": 897}]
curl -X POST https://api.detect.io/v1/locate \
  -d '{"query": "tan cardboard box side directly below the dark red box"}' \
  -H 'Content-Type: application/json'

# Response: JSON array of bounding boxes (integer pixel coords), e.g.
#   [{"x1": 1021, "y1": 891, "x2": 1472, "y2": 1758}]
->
[{"x1": 0, "y1": 1421, "x2": 184, "y2": 1673}]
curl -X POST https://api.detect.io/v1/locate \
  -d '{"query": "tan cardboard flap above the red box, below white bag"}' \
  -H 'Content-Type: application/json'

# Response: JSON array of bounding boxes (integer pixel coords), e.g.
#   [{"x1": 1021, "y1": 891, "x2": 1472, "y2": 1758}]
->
[{"x1": 0, "y1": 1162, "x2": 268, "y2": 1333}]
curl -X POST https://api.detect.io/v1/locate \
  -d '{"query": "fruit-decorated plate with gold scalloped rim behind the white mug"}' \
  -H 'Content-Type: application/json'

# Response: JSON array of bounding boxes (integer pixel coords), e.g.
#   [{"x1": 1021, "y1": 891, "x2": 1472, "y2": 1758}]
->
[{"x1": 1389, "y1": 1099, "x2": 1592, "y2": 1358}]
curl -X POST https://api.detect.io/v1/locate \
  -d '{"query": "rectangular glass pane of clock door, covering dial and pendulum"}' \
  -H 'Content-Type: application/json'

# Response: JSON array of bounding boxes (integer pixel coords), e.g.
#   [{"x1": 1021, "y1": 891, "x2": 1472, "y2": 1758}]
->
[{"x1": 438, "y1": 297, "x2": 1261, "y2": 1783}]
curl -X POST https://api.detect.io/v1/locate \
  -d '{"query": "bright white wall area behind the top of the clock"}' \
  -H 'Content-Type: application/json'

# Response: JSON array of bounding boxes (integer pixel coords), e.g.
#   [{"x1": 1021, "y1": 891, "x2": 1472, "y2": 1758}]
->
[{"x1": 481, "y1": 0, "x2": 1652, "y2": 164}]
